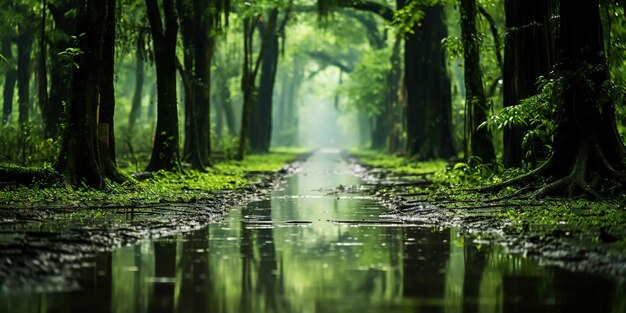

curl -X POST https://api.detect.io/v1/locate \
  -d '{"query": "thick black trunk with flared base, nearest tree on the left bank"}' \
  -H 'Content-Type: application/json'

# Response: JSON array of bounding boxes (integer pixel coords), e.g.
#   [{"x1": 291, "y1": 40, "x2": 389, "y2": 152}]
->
[{"x1": 55, "y1": 0, "x2": 107, "y2": 188}]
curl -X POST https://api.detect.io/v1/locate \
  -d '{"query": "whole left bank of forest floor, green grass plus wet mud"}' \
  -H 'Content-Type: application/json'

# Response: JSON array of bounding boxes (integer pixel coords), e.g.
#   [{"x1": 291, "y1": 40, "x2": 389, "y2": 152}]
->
[{"x1": 0, "y1": 150, "x2": 307, "y2": 292}]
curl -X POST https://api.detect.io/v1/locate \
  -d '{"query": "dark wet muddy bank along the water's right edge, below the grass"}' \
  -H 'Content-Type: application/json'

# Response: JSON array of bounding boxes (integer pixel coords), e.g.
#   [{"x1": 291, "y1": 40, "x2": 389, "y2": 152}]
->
[{"x1": 350, "y1": 157, "x2": 626, "y2": 281}]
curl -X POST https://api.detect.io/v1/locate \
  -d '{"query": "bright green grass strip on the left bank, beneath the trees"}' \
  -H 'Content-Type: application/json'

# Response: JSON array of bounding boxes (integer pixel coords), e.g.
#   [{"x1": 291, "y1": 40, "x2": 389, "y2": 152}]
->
[{"x1": 0, "y1": 149, "x2": 301, "y2": 208}]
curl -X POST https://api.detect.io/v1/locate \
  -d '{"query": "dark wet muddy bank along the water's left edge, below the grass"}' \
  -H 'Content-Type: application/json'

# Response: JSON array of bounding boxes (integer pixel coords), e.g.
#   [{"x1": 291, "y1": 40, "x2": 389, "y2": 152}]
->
[{"x1": 0, "y1": 158, "x2": 308, "y2": 293}]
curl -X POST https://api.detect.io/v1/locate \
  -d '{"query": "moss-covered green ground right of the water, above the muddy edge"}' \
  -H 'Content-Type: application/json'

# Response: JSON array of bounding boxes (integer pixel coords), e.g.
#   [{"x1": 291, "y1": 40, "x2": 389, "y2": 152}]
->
[{"x1": 352, "y1": 151, "x2": 626, "y2": 255}]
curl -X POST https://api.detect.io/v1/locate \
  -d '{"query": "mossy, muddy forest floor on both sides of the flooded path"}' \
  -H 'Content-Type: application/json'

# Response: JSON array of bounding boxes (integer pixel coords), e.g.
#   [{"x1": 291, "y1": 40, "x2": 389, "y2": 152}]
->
[{"x1": 0, "y1": 151, "x2": 626, "y2": 292}]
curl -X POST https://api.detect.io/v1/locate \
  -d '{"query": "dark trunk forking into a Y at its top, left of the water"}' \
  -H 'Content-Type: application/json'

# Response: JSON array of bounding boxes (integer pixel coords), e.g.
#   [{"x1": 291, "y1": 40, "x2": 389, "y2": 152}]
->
[{"x1": 145, "y1": 0, "x2": 180, "y2": 171}]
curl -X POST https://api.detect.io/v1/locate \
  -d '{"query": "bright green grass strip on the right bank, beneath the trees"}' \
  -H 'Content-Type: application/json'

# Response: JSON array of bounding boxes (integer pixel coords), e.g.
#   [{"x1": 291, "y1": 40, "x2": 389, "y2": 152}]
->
[{"x1": 353, "y1": 151, "x2": 626, "y2": 252}]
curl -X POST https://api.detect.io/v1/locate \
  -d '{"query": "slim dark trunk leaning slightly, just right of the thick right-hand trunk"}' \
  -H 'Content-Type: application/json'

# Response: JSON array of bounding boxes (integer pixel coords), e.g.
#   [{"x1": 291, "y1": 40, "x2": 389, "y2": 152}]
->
[{"x1": 460, "y1": 0, "x2": 496, "y2": 163}]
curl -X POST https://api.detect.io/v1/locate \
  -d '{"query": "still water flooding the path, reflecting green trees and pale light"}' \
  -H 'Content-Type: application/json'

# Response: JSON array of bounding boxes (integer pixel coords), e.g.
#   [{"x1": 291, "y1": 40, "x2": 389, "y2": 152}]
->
[{"x1": 0, "y1": 150, "x2": 626, "y2": 313}]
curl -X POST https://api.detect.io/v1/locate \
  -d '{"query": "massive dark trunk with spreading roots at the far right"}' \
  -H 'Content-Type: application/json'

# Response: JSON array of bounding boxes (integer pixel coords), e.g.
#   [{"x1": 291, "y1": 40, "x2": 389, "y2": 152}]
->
[{"x1": 537, "y1": 0, "x2": 626, "y2": 197}]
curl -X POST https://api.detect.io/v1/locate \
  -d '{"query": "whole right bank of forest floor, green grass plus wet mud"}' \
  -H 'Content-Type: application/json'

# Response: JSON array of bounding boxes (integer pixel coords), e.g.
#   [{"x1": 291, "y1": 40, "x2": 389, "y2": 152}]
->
[{"x1": 351, "y1": 151, "x2": 626, "y2": 280}]
